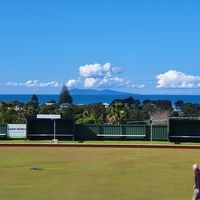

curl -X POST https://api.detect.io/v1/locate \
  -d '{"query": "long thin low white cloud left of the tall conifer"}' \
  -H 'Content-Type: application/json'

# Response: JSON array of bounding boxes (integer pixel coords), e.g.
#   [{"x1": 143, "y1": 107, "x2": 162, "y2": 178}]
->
[{"x1": 6, "y1": 80, "x2": 61, "y2": 87}]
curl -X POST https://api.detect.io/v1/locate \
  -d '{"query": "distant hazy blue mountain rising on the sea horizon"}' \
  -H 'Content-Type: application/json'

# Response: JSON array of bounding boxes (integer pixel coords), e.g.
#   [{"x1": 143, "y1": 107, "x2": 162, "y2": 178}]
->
[{"x1": 69, "y1": 89, "x2": 133, "y2": 96}]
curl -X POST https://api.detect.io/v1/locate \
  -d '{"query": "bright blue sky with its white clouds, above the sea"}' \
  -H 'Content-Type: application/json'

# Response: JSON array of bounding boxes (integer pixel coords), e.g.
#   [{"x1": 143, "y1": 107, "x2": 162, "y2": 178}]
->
[{"x1": 0, "y1": 0, "x2": 200, "y2": 94}]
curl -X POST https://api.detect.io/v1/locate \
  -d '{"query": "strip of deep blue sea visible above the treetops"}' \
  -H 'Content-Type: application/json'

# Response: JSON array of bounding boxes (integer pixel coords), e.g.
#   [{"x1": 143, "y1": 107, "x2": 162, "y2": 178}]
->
[{"x1": 0, "y1": 94, "x2": 200, "y2": 104}]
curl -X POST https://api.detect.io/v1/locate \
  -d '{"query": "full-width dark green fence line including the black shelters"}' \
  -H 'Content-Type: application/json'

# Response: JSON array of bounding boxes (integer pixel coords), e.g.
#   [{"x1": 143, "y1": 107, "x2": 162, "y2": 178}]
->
[{"x1": 0, "y1": 118, "x2": 200, "y2": 142}]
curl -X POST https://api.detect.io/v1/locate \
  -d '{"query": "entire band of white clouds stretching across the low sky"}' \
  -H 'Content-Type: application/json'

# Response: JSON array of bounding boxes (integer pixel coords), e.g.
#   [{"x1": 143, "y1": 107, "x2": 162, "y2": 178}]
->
[{"x1": 3, "y1": 67, "x2": 200, "y2": 94}]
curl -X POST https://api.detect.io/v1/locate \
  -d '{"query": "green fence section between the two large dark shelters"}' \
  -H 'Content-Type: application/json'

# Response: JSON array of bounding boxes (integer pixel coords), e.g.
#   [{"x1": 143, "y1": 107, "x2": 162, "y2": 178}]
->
[{"x1": 75, "y1": 124, "x2": 169, "y2": 141}]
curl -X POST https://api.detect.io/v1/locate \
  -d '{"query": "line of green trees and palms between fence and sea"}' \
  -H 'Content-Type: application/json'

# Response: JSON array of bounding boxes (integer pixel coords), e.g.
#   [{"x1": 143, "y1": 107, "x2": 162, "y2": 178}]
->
[{"x1": 0, "y1": 86, "x2": 200, "y2": 124}]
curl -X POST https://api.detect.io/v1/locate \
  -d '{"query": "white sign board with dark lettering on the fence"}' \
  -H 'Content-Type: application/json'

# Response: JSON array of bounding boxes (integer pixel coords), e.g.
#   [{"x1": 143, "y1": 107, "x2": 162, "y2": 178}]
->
[{"x1": 7, "y1": 124, "x2": 26, "y2": 138}]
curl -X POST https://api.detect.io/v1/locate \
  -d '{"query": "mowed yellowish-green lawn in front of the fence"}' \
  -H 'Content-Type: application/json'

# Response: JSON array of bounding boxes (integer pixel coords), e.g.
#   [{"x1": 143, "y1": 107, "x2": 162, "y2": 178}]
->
[{"x1": 0, "y1": 147, "x2": 200, "y2": 200}]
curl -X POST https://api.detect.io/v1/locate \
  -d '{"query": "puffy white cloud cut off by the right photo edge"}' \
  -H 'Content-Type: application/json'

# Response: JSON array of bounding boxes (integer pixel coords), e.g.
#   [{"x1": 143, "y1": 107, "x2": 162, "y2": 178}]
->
[{"x1": 156, "y1": 70, "x2": 200, "y2": 88}]
